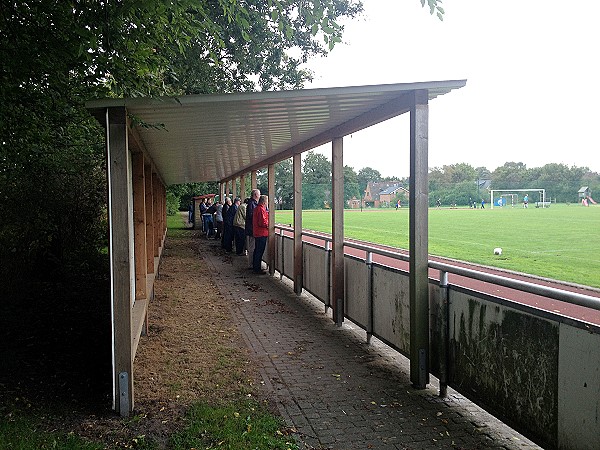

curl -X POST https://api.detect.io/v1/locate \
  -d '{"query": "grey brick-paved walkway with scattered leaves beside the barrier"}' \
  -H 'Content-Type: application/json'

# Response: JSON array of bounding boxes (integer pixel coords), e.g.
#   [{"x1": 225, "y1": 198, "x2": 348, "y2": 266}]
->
[{"x1": 201, "y1": 239, "x2": 540, "y2": 450}]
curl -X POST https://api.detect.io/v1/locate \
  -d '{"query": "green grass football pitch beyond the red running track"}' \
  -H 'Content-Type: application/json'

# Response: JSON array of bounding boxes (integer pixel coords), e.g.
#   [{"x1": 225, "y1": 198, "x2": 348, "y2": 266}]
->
[{"x1": 275, "y1": 205, "x2": 600, "y2": 287}]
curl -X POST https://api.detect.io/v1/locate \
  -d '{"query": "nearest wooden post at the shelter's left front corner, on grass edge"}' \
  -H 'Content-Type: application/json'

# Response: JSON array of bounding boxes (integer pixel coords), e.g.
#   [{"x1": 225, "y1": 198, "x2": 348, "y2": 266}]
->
[{"x1": 106, "y1": 107, "x2": 135, "y2": 416}]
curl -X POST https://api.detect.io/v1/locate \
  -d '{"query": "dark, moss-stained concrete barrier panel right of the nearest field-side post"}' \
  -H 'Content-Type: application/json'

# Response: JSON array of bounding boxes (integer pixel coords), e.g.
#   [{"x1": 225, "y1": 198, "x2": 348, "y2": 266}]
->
[{"x1": 448, "y1": 289, "x2": 559, "y2": 443}]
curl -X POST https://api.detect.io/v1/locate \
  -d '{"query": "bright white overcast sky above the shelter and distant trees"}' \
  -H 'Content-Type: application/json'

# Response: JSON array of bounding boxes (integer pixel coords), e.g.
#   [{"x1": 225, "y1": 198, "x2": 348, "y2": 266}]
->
[{"x1": 306, "y1": 0, "x2": 600, "y2": 177}]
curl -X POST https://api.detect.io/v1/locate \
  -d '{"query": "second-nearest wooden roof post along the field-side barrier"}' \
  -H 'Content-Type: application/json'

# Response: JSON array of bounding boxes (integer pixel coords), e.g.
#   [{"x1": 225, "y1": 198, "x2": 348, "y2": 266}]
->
[{"x1": 331, "y1": 138, "x2": 345, "y2": 326}]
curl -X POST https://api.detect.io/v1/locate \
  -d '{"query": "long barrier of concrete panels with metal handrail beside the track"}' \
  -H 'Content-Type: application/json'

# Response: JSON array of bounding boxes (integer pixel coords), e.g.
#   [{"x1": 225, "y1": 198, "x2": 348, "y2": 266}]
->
[{"x1": 275, "y1": 226, "x2": 600, "y2": 449}]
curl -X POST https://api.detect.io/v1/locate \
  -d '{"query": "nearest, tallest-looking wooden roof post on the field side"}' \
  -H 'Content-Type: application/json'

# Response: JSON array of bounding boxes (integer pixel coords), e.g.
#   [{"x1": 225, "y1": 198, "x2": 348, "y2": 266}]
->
[{"x1": 409, "y1": 90, "x2": 429, "y2": 389}]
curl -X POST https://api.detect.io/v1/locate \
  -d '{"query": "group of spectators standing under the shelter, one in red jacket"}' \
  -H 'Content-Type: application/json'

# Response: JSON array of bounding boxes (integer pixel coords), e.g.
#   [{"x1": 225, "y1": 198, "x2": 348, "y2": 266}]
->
[{"x1": 200, "y1": 189, "x2": 269, "y2": 274}]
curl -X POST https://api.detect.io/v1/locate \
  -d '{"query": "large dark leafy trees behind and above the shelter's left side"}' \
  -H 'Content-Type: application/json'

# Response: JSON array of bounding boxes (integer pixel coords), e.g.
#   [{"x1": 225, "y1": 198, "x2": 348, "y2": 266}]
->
[{"x1": 0, "y1": 0, "x2": 362, "y2": 279}]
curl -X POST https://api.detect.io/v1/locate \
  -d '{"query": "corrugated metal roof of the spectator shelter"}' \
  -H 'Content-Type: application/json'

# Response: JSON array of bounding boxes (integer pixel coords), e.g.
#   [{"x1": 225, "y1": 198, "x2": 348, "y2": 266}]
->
[{"x1": 86, "y1": 80, "x2": 466, "y2": 185}]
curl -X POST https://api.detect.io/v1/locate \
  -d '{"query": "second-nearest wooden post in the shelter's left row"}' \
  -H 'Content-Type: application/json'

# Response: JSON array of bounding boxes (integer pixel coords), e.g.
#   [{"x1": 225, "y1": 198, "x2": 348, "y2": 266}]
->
[{"x1": 131, "y1": 153, "x2": 148, "y2": 300}]
